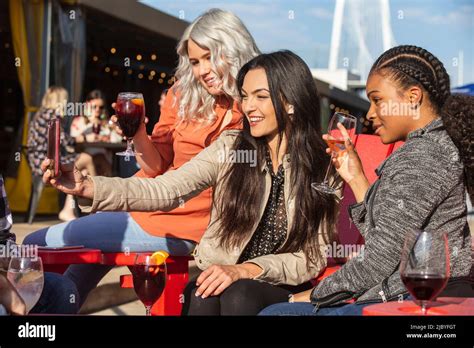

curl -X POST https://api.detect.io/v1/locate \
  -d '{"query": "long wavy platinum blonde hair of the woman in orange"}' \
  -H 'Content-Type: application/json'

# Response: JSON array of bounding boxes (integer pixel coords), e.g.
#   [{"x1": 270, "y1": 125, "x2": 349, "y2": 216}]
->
[{"x1": 175, "y1": 9, "x2": 260, "y2": 122}]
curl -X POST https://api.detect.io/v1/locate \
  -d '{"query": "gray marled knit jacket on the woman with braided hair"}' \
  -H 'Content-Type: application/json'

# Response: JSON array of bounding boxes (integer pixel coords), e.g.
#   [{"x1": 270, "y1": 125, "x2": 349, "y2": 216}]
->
[{"x1": 311, "y1": 119, "x2": 472, "y2": 306}]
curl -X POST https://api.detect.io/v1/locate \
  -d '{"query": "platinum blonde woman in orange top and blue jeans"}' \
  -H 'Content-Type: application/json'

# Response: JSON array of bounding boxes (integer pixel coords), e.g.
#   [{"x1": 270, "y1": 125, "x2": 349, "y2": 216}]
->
[{"x1": 24, "y1": 9, "x2": 259, "y2": 308}]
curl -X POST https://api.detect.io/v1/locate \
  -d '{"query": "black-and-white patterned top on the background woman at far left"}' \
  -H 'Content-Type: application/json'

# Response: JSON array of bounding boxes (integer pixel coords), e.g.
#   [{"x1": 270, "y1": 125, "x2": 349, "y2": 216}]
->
[{"x1": 27, "y1": 108, "x2": 77, "y2": 175}]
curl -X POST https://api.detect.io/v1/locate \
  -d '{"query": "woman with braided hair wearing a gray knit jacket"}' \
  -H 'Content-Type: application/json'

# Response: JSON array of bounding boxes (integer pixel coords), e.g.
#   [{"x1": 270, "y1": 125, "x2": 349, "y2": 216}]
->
[{"x1": 260, "y1": 45, "x2": 474, "y2": 315}]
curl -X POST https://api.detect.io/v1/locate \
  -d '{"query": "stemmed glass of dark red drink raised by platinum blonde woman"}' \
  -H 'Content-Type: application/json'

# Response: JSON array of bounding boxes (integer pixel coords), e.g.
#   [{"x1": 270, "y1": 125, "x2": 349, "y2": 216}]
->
[{"x1": 115, "y1": 92, "x2": 145, "y2": 157}]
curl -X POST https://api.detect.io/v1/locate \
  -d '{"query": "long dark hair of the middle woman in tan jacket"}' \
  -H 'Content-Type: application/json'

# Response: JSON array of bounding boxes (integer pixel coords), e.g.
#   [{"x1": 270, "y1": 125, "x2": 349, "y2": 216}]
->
[{"x1": 213, "y1": 51, "x2": 338, "y2": 268}]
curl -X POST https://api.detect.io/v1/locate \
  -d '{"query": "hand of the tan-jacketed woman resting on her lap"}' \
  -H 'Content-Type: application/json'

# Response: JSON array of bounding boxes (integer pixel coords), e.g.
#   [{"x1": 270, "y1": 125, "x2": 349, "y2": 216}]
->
[{"x1": 196, "y1": 264, "x2": 261, "y2": 298}]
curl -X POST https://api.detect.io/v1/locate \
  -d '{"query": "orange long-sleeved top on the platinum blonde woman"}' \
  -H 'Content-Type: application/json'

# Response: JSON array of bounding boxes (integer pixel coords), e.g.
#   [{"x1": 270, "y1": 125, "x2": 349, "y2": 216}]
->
[{"x1": 130, "y1": 88, "x2": 242, "y2": 242}]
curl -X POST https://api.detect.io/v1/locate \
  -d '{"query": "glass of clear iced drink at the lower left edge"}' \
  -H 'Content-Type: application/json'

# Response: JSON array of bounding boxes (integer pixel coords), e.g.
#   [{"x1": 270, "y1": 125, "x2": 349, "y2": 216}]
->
[{"x1": 7, "y1": 257, "x2": 44, "y2": 313}]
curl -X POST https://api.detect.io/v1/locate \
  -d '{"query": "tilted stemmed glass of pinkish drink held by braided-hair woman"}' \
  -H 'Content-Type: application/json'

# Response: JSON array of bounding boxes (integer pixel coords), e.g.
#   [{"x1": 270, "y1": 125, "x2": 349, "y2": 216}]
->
[{"x1": 311, "y1": 112, "x2": 357, "y2": 194}]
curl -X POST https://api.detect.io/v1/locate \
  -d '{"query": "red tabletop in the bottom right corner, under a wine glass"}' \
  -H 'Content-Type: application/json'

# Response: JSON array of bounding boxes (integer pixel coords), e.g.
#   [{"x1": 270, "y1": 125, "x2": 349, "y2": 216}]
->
[{"x1": 362, "y1": 297, "x2": 474, "y2": 316}]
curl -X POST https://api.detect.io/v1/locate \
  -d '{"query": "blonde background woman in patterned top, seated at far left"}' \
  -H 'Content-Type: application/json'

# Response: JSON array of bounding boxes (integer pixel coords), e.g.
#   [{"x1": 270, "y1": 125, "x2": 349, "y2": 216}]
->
[{"x1": 27, "y1": 86, "x2": 97, "y2": 221}]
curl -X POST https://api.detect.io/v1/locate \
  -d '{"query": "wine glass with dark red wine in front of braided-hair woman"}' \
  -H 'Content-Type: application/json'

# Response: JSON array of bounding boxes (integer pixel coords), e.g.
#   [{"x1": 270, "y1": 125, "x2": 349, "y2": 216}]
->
[{"x1": 400, "y1": 231, "x2": 450, "y2": 315}]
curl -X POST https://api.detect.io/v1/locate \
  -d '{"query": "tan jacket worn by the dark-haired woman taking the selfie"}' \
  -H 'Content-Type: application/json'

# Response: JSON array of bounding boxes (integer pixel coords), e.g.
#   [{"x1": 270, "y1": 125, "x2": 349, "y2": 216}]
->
[{"x1": 80, "y1": 130, "x2": 334, "y2": 285}]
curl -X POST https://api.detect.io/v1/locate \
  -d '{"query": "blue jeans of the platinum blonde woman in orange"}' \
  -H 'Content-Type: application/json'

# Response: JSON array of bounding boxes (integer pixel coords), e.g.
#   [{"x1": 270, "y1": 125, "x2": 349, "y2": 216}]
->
[{"x1": 23, "y1": 212, "x2": 196, "y2": 305}]
